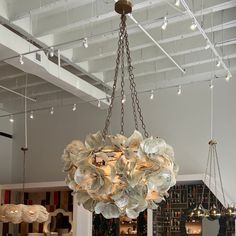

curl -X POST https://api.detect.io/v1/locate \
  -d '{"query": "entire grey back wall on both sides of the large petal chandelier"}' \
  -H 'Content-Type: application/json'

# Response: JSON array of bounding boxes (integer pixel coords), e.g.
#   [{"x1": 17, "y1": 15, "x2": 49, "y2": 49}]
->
[{"x1": 6, "y1": 77, "x2": 236, "y2": 205}]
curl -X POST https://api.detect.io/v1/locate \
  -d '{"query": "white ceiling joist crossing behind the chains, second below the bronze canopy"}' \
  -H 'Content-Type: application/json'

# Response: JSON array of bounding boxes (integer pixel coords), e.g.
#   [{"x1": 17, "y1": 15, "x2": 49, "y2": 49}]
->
[{"x1": 73, "y1": 8, "x2": 236, "y2": 63}]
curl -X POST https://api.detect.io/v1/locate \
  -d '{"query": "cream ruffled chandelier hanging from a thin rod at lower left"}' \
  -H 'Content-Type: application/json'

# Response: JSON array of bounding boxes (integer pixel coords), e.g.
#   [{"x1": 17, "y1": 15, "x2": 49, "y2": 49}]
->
[{"x1": 0, "y1": 74, "x2": 49, "y2": 224}]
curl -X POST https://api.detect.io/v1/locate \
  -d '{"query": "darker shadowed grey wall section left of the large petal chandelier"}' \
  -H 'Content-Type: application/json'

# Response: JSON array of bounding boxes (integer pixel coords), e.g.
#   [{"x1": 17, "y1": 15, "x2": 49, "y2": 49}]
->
[{"x1": 12, "y1": 104, "x2": 105, "y2": 183}]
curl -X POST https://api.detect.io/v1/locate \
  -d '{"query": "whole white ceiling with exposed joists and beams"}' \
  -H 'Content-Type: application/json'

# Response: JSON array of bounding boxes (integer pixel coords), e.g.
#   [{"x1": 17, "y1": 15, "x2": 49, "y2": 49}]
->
[{"x1": 0, "y1": 0, "x2": 236, "y2": 112}]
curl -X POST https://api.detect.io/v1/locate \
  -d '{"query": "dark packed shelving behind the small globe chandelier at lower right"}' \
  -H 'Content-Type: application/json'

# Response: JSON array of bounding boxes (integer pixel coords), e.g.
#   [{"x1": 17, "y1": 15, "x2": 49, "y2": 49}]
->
[{"x1": 153, "y1": 183, "x2": 235, "y2": 236}]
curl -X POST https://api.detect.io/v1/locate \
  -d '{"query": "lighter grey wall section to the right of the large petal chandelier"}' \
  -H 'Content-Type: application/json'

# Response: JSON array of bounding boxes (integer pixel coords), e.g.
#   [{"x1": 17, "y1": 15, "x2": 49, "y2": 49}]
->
[{"x1": 112, "y1": 79, "x2": 236, "y2": 202}]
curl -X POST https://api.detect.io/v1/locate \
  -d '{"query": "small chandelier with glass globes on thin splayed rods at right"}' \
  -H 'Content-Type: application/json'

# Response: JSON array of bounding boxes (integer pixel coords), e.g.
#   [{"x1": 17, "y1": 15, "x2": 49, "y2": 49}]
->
[{"x1": 190, "y1": 81, "x2": 236, "y2": 220}]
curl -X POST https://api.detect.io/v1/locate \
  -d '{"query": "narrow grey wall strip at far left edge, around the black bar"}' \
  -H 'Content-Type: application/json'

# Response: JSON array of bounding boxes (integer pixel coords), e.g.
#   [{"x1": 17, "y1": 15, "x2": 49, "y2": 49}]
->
[{"x1": 0, "y1": 111, "x2": 12, "y2": 184}]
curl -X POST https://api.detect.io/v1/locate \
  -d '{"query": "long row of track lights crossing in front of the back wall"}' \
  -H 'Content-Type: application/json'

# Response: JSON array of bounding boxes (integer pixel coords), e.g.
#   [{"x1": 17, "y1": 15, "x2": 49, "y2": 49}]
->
[{"x1": 5, "y1": 77, "x2": 227, "y2": 123}]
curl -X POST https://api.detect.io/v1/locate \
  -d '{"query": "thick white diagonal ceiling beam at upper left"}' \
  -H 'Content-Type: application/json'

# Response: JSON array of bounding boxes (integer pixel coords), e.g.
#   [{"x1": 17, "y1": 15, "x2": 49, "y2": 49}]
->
[{"x1": 0, "y1": 26, "x2": 107, "y2": 104}]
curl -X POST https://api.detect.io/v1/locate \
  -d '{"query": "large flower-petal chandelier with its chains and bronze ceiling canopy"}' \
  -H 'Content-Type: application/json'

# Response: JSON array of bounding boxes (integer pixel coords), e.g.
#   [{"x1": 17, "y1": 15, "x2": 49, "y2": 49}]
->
[{"x1": 63, "y1": 0, "x2": 178, "y2": 219}]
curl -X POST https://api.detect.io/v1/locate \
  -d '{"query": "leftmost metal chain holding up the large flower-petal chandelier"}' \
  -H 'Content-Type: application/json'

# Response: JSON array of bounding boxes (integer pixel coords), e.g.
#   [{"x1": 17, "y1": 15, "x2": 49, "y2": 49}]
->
[{"x1": 102, "y1": 15, "x2": 125, "y2": 137}]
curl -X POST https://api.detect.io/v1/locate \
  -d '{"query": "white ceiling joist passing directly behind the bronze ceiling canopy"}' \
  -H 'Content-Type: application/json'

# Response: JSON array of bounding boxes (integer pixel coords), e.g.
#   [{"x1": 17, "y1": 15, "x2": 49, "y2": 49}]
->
[{"x1": 34, "y1": 0, "x2": 164, "y2": 37}]
